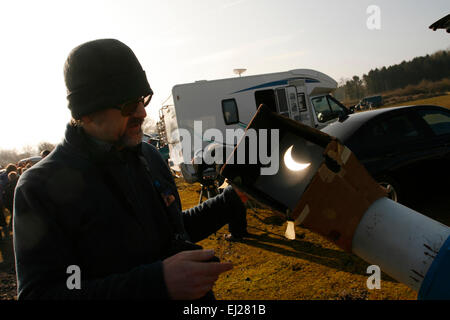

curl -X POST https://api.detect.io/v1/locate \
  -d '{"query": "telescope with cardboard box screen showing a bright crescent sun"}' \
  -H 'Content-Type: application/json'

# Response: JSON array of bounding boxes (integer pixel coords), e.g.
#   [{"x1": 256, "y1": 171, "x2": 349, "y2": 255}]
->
[{"x1": 221, "y1": 105, "x2": 450, "y2": 299}]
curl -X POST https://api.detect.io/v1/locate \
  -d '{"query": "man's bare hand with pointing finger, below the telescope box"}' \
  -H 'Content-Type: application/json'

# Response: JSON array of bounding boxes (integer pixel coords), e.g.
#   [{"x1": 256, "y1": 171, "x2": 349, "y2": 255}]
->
[{"x1": 163, "y1": 250, "x2": 233, "y2": 300}]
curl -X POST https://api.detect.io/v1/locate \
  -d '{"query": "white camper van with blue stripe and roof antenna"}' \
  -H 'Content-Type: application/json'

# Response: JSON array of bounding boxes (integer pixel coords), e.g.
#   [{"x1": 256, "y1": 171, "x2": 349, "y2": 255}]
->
[{"x1": 162, "y1": 69, "x2": 349, "y2": 180}]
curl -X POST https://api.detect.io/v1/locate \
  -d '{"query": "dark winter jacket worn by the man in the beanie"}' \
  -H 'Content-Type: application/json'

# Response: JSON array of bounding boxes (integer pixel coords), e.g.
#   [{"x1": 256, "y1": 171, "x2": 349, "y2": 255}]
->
[{"x1": 14, "y1": 125, "x2": 245, "y2": 299}]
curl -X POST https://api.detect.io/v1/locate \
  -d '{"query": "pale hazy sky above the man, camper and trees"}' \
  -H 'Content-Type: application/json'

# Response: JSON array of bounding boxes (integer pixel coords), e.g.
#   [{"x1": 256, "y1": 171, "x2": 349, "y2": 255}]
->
[{"x1": 0, "y1": 0, "x2": 450, "y2": 150}]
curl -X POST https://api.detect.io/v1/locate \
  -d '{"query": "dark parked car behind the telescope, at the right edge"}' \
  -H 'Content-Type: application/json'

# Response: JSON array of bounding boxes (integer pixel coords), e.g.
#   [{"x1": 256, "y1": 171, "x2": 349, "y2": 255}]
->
[{"x1": 322, "y1": 105, "x2": 450, "y2": 203}]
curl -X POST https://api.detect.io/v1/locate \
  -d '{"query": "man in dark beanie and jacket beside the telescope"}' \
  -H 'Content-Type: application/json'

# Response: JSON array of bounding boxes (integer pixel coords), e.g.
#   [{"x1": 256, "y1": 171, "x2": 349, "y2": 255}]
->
[{"x1": 14, "y1": 39, "x2": 250, "y2": 299}]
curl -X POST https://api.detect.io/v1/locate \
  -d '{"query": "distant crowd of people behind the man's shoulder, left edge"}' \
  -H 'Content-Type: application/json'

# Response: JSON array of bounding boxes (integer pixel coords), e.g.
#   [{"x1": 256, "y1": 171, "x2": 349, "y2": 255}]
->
[{"x1": 0, "y1": 150, "x2": 50, "y2": 240}]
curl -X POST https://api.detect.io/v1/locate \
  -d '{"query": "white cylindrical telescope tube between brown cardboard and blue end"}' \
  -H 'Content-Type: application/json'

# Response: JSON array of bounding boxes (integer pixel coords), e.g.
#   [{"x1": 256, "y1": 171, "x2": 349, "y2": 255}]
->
[{"x1": 352, "y1": 198, "x2": 450, "y2": 291}]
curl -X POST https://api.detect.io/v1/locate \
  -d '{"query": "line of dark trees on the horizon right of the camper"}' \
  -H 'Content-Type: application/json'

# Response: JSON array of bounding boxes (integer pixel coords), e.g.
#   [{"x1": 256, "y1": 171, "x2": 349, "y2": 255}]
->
[{"x1": 336, "y1": 49, "x2": 450, "y2": 100}]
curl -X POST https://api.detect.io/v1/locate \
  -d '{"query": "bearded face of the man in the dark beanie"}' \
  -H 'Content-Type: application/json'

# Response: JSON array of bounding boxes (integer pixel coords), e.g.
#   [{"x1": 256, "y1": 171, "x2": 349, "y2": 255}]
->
[{"x1": 83, "y1": 102, "x2": 147, "y2": 148}]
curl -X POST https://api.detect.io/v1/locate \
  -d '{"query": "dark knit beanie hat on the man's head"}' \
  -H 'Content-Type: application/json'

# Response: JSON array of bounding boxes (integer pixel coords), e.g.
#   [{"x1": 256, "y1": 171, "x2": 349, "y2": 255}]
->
[{"x1": 64, "y1": 39, "x2": 153, "y2": 119}]
